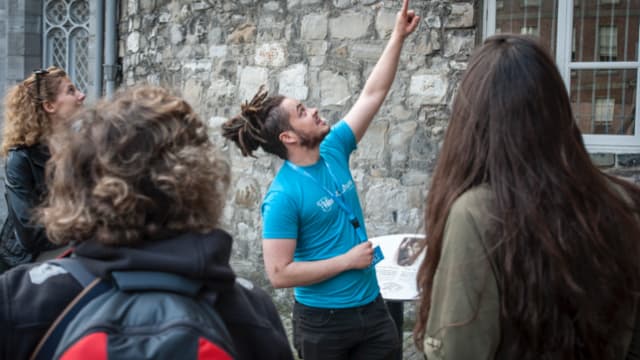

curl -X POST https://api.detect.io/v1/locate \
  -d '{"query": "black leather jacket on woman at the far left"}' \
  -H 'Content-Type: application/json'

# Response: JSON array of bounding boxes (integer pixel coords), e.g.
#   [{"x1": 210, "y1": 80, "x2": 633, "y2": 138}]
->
[{"x1": 0, "y1": 144, "x2": 54, "y2": 272}]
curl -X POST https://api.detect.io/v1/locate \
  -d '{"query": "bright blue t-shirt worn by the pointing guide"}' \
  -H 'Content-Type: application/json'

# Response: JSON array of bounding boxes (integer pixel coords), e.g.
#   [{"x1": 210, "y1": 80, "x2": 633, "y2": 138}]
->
[{"x1": 262, "y1": 121, "x2": 380, "y2": 308}]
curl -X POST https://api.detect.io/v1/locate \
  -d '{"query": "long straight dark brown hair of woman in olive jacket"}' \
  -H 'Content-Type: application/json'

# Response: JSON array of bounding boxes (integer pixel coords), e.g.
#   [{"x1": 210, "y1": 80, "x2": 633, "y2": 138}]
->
[{"x1": 414, "y1": 35, "x2": 640, "y2": 359}]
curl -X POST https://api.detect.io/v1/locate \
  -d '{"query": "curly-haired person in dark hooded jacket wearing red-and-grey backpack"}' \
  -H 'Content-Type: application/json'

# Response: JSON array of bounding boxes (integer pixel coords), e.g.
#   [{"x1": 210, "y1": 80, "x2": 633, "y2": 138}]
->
[{"x1": 0, "y1": 87, "x2": 293, "y2": 360}]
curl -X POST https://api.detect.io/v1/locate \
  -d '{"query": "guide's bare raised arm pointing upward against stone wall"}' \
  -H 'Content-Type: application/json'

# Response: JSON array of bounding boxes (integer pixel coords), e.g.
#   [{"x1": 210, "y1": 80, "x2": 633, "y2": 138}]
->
[{"x1": 345, "y1": 0, "x2": 420, "y2": 142}]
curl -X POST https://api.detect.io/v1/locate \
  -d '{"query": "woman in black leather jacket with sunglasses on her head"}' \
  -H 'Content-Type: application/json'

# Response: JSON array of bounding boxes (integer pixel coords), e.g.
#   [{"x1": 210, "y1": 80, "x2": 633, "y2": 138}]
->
[{"x1": 0, "y1": 66, "x2": 85, "y2": 273}]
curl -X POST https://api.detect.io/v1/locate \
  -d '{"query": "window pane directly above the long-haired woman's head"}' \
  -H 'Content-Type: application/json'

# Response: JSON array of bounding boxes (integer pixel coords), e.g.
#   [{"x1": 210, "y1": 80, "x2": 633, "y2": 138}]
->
[{"x1": 496, "y1": 0, "x2": 558, "y2": 56}]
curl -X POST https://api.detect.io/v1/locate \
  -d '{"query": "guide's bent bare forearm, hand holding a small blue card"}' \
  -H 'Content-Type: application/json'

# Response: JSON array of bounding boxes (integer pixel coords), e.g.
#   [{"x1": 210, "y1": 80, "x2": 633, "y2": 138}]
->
[{"x1": 262, "y1": 239, "x2": 373, "y2": 288}]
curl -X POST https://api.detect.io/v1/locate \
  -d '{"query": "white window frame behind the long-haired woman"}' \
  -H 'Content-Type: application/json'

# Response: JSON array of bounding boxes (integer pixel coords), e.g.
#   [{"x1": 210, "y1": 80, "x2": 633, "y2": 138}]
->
[{"x1": 482, "y1": 0, "x2": 640, "y2": 153}]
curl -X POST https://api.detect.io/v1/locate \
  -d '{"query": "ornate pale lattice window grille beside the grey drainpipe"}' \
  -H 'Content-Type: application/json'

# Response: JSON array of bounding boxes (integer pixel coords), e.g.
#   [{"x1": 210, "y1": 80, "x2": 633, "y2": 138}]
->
[{"x1": 43, "y1": 0, "x2": 89, "y2": 93}]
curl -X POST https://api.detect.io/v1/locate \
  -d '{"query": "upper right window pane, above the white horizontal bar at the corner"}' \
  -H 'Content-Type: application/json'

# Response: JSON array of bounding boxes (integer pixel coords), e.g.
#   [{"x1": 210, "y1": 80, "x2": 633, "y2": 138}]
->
[{"x1": 571, "y1": 0, "x2": 640, "y2": 62}]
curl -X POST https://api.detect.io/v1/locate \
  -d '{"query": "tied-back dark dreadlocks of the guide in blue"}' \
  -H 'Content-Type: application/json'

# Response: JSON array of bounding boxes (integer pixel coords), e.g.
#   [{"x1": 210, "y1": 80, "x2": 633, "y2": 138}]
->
[{"x1": 222, "y1": 85, "x2": 290, "y2": 159}]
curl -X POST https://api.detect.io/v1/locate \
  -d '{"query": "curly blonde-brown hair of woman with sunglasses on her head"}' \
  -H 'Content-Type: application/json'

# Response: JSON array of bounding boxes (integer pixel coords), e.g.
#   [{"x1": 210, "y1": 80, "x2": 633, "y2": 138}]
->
[{"x1": 0, "y1": 66, "x2": 67, "y2": 156}]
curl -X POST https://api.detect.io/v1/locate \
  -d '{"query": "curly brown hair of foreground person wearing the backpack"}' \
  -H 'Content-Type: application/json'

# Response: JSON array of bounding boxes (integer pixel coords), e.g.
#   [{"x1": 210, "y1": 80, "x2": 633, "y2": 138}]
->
[{"x1": 39, "y1": 86, "x2": 230, "y2": 245}]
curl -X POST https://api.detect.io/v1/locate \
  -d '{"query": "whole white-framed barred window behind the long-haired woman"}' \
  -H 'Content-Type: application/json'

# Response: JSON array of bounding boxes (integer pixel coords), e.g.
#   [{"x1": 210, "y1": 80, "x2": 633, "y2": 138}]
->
[{"x1": 483, "y1": 0, "x2": 640, "y2": 152}]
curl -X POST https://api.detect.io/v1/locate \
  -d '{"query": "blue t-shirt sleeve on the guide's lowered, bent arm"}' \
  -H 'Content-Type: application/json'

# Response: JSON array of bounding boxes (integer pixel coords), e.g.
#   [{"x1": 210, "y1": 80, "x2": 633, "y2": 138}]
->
[{"x1": 262, "y1": 191, "x2": 298, "y2": 239}]
